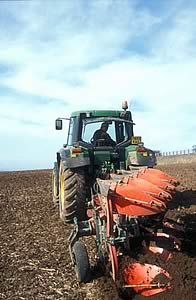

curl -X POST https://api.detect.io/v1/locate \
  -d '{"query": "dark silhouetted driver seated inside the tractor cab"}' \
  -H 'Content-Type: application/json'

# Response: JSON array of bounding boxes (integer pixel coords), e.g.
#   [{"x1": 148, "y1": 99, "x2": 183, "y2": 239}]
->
[{"x1": 92, "y1": 122, "x2": 116, "y2": 146}]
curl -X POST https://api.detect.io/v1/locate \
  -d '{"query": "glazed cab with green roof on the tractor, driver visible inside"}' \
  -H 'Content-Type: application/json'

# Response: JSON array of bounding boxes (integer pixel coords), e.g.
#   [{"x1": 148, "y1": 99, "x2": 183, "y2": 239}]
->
[{"x1": 67, "y1": 110, "x2": 134, "y2": 148}]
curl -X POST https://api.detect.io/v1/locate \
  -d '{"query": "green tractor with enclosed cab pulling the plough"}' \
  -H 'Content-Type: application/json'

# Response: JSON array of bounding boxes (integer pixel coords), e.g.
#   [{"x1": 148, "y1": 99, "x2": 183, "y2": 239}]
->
[{"x1": 53, "y1": 101, "x2": 156, "y2": 223}]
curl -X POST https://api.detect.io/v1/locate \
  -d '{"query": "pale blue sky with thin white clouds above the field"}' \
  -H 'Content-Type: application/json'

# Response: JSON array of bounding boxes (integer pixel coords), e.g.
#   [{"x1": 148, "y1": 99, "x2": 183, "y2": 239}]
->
[{"x1": 0, "y1": 0, "x2": 196, "y2": 170}]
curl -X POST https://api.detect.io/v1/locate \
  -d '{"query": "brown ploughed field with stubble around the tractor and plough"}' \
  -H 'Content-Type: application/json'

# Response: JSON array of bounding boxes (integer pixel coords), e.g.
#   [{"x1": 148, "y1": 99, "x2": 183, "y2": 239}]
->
[{"x1": 0, "y1": 164, "x2": 196, "y2": 300}]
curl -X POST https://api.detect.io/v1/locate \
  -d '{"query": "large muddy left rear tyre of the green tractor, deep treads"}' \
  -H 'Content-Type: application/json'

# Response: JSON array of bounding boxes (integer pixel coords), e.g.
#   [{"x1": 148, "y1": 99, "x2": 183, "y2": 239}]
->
[{"x1": 59, "y1": 162, "x2": 87, "y2": 223}]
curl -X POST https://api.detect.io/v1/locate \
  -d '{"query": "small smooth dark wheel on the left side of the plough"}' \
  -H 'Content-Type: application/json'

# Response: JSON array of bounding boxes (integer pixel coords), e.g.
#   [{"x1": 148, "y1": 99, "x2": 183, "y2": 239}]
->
[{"x1": 72, "y1": 241, "x2": 90, "y2": 282}]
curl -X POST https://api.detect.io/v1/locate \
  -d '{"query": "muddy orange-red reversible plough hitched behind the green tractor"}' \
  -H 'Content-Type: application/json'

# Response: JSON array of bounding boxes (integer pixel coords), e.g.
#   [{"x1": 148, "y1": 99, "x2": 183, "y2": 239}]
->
[{"x1": 70, "y1": 168, "x2": 180, "y2": 296}]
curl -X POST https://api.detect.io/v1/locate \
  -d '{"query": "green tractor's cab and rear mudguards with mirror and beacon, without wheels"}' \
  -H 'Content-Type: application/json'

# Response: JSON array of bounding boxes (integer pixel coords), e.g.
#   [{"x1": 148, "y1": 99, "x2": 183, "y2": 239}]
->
[{"x1": 56, "y1": 101, "x2": 156, "y2": 174}]
